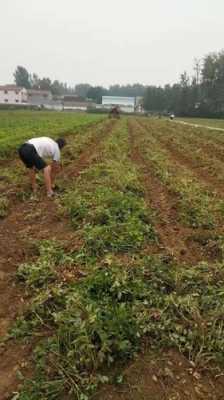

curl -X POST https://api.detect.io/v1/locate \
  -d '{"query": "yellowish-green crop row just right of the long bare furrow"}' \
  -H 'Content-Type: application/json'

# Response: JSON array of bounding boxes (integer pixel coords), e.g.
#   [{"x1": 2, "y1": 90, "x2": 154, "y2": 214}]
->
[{"x1": 131, "y1": 119, "x2": 224, "y2": 228}]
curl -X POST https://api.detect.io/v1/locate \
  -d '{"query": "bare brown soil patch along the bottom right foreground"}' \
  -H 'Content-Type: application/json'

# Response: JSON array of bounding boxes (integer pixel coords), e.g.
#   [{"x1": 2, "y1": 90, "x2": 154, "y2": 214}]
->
[{"x1": 92, "y1": 351, "x2": 224, "y2": 400}]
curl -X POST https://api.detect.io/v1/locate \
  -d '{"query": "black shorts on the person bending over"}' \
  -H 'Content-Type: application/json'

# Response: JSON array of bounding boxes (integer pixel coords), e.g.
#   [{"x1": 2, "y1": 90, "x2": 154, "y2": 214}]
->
[{"x1": 18, "y1": 143, "x2": 47, "y2": 171}]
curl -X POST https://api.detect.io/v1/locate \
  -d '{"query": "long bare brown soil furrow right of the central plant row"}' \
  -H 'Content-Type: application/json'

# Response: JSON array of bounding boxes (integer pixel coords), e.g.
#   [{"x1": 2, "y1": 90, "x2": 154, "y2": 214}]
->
[{"x1": 129, "y1": 120, "x2": 213, "y2": 264}]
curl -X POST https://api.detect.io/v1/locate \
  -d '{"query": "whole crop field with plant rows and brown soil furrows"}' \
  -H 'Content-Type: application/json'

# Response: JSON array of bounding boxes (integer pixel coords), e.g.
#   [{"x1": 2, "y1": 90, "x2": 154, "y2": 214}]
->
[{"x1": 0, "y1": 113, "x2": 224, "y2": 400}]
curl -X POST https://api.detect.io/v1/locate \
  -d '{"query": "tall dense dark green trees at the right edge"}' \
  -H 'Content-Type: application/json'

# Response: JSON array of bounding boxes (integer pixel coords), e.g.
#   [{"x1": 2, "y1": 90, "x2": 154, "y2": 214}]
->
[{"x1": 144, "y1": 51, "x2": 224, "y2": 117}]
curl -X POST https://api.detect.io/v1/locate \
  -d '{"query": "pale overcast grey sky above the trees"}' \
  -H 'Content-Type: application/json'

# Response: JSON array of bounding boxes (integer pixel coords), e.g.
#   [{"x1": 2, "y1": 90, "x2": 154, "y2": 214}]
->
[{"x1": 0, "y1": 0, "x2": 224, "y2": 87}]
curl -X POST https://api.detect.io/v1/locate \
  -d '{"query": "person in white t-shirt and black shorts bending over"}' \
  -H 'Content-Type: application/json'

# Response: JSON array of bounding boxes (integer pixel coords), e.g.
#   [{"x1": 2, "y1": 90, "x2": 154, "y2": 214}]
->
[{"x1": 18, "y1": 137, "x2": 66, "y2": 197}]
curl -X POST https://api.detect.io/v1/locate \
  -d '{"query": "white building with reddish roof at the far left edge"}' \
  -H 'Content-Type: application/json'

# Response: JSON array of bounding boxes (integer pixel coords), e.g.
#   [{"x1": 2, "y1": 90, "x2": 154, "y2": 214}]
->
[{"x1": 0, "y1": 85, "x2": 28, "y2": 104}]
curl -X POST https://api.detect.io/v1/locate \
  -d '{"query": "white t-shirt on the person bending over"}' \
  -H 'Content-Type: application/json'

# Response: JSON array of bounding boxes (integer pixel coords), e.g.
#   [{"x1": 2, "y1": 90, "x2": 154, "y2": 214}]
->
[{"x1": 27, "y1": 137, "x2": 60, "y2": 161}]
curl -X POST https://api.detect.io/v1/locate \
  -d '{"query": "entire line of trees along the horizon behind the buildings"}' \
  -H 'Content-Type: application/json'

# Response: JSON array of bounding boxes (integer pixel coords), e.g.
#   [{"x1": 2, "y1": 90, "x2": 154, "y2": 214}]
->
[{"x1": 14, "y1": 50, "x2": 224, "y2": 117}]
